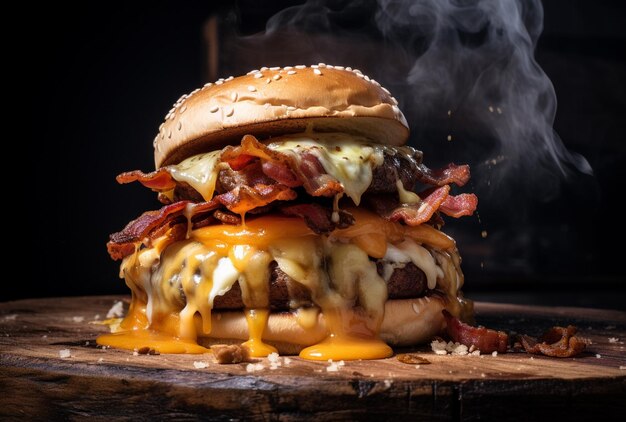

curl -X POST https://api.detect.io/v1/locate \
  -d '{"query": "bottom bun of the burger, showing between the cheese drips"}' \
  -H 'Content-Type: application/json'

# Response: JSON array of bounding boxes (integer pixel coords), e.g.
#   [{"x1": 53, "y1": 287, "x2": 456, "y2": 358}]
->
[{"x1": 197, "y1": 295, "x2": 446, "y2": 355}]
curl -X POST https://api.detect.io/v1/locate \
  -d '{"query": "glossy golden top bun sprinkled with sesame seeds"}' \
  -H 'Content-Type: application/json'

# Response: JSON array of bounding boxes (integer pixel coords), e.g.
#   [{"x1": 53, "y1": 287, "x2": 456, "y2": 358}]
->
[{"x1": 154, "y1": 63, "x2": 409, "y2": 168}]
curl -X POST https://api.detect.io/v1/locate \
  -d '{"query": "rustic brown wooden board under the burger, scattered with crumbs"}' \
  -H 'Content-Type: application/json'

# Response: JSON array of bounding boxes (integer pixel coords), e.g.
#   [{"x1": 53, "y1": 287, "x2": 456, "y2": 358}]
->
[{"x1": 0, "y1": 296, "x2": 626, "y2": 420}]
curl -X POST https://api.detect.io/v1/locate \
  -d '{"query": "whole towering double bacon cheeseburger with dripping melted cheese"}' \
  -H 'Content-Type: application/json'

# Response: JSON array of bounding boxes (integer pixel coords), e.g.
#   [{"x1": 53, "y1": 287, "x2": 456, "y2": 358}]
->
[{"x1": 98, "y1": 64, "x2": 477, "y2": 360}]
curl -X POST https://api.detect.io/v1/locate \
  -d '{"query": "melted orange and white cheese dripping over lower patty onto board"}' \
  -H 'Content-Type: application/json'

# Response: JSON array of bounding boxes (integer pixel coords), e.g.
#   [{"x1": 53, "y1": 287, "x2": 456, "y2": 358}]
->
[{"x1": 98, "y1": 209, "x2": 462, "y2": 360}]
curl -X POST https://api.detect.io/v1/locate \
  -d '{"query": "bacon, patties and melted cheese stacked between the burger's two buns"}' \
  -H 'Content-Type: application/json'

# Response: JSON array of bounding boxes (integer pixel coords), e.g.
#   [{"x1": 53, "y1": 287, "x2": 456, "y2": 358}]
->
[{"x1": 98, "y1": 133, "x2": 477, "y2": 360}]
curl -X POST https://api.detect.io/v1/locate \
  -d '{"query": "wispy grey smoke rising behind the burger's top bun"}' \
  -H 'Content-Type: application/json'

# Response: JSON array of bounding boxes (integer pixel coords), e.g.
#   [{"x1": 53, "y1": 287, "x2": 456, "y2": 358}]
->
[{"x1": 222, "y1": 0, "x2": 591, "y2": 200}]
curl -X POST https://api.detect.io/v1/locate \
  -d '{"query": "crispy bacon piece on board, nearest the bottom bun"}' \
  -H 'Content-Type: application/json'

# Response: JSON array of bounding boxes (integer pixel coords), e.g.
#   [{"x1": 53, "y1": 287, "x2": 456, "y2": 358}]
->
[{"x1": 441, "y1": 309, "x2": 509, "y2": 353}]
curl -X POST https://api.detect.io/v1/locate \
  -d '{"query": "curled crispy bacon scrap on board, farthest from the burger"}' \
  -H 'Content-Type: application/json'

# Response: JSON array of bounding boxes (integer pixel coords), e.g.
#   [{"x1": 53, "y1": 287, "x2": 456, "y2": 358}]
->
[{"x1": 520, "y1": 325, "x2": 589, "y2": 358}]
